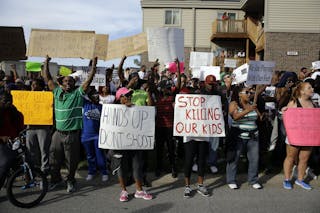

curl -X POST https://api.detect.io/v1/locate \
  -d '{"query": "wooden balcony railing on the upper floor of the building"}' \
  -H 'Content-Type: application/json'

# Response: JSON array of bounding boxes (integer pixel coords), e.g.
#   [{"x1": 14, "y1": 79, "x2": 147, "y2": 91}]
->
[{"x1": 212, "y1": 19, "x2": 247, "y2": 34}]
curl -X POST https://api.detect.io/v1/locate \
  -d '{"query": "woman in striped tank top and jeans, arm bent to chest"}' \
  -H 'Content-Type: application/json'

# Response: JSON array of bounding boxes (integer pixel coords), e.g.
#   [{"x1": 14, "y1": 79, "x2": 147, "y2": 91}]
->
[{"x1": 226, "y1": 86, "x2": 262, "y2": 189}]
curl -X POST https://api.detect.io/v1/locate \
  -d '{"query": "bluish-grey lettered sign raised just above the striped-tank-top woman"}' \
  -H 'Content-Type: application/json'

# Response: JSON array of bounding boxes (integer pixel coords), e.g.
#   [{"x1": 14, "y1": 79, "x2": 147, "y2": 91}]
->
[{"x1": 246, "y1": 61, "x2": 275, "y2": 85}]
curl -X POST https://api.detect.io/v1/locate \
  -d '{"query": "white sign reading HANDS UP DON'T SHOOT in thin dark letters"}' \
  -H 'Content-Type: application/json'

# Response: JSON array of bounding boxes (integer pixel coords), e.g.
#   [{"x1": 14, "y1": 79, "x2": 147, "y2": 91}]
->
[{"x1": 99, "y1": 104, "x2": 155, "y2": 150}]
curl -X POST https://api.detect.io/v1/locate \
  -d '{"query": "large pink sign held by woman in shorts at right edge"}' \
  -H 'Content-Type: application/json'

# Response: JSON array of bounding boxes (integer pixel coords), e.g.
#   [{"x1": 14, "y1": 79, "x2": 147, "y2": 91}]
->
[{"x1": 283, "y1": 108, "x2": 320, "y2": 146}]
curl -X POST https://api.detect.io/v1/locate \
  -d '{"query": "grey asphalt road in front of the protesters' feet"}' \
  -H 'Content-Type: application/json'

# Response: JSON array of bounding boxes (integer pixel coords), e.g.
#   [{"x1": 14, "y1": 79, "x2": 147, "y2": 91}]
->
[{"x1": 0, "y1": 171, "x2": 320, "y2": 213}]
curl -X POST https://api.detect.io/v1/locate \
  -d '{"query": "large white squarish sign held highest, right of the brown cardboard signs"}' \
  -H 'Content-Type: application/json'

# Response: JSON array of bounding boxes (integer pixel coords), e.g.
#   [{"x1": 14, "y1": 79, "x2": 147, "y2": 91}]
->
[{"x1": 147, "y1": 27, "x2": 184, "y2": 64}]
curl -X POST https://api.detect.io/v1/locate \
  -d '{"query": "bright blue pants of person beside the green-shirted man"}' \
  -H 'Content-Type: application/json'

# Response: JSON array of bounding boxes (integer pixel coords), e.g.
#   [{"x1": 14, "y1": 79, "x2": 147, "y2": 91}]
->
[{"x1": 82, "y1": 138, "x2": 108, "y2": 175}]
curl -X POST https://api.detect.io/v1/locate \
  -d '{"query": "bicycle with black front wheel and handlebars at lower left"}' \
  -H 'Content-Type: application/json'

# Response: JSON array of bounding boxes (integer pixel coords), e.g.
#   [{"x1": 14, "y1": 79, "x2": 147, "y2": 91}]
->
[{"x1": 0, "y1": 130, "x2": 48, "y2": 208}]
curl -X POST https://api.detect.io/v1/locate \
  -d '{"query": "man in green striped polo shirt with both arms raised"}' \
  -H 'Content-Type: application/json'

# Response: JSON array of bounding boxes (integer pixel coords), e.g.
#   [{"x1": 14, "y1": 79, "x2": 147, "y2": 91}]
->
[{"x1": 44, "y1": 56, "x2": 97, "y2": 193}]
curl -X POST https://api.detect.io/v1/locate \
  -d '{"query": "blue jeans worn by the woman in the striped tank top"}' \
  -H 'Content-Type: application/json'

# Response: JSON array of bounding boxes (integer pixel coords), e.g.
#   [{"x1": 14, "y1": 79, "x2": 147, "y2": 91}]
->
[{"x1": 226, "y1": 139, "x2": 259, "y2": 185}]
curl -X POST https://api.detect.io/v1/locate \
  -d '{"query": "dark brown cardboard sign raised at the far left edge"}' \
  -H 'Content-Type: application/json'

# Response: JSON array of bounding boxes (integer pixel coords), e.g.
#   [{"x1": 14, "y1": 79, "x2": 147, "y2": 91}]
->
[{"x1": 0, "y1": 27, "x2": 26, "y2": 61}]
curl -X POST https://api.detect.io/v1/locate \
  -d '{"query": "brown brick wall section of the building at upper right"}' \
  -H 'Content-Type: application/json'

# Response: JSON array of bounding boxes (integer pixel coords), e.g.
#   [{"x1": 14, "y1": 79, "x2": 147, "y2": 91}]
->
[{"x1": 264, "y1": 32, "x2": 320, "y2": 72}]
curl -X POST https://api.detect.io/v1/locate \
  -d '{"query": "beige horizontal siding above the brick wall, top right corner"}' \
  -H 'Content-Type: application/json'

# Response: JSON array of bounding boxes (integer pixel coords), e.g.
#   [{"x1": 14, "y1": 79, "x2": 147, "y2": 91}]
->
[{"x1": 265, "y1": 0, "x2": 320, "y2": 33}]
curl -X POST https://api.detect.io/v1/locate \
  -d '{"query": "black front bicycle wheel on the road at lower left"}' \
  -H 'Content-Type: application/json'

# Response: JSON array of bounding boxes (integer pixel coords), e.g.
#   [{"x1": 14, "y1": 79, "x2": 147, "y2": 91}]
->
[{"x1": 7, "y1": 167, "x2": 48, "y2": 208}]
